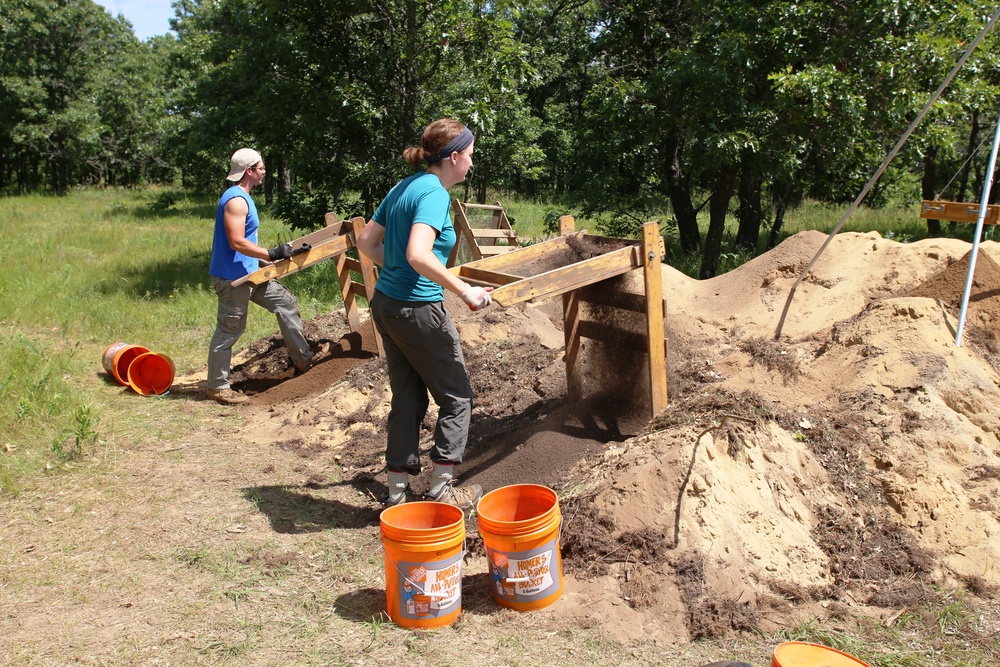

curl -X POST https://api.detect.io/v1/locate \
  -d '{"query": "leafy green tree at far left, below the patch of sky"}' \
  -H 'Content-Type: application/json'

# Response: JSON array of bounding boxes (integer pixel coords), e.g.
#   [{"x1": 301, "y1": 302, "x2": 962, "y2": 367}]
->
[{"x1": 0, "y1": 0, "x2": 170, "y2": 192}]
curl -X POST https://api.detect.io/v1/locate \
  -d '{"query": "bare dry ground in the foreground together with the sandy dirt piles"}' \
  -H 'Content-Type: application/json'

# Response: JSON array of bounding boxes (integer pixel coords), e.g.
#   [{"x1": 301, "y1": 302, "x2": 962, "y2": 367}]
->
[{"x1": 0, "y1": 232, "x2": 1000, "y2": 665}]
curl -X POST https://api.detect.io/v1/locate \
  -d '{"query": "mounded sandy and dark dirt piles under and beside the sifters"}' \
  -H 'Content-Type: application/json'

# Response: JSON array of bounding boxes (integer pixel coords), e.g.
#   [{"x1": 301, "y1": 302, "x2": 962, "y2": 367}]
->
[{"x1": 219, "y1": 232, "x2": 1000, "y2": 642}]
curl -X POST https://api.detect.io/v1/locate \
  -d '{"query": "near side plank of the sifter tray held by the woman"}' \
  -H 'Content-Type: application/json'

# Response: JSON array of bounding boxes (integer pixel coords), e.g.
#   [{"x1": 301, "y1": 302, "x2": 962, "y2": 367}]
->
[{"x1": 493, "y1": 246, "x2": 642, "y2": 306}]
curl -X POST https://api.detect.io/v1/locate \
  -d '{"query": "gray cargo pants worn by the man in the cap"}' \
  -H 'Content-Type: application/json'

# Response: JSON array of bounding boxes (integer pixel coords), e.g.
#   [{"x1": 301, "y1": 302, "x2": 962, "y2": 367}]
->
[{"x1": 208, "y1": 276, "x2": 311, "y2": 389}]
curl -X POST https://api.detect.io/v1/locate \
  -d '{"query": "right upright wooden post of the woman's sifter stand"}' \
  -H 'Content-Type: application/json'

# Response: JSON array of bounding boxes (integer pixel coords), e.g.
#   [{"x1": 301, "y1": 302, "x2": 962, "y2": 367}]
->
[{"x1": 642, "y1": 222, "x2": 667, "y2": 417}]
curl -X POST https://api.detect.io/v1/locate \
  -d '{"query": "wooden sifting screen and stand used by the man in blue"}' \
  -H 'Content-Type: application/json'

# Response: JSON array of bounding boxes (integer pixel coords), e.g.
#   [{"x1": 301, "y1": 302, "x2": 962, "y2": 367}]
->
[{"x1": 233, "y1": 213, "x2": 385, "y2": 356}]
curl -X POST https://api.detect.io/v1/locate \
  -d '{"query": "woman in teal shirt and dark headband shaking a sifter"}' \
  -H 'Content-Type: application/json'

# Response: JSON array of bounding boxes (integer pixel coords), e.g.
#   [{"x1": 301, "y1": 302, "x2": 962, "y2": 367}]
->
[{"x1": 358, "y1": 118, "x2": 492, "y2": 509}]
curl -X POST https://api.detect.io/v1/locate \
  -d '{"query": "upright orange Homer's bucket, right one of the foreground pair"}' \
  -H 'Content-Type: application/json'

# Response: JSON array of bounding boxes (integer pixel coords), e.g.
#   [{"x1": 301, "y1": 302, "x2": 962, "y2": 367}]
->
[{"x1": 476, "y1": 484, "x2": 563, "y2": 611}]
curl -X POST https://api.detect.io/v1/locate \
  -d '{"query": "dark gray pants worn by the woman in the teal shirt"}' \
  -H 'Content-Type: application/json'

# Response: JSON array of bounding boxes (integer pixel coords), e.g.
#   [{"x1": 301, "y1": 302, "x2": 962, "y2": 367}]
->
[{"x1": 371, "y1": 290, "x2": 472, "y2": 475}]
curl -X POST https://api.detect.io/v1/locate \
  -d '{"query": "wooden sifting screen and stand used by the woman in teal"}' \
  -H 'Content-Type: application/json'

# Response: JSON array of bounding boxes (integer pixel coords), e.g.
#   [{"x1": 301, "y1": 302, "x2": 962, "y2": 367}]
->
[{"x1": 449, "y1": 216, "x2": 667, "y2": 416}]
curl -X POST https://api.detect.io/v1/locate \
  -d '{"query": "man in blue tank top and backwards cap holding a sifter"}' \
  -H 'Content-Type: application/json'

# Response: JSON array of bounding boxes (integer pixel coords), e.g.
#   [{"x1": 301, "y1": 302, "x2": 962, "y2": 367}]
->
[{"x1": 206, "y1": 148, "x2": 316, "y2": 405}]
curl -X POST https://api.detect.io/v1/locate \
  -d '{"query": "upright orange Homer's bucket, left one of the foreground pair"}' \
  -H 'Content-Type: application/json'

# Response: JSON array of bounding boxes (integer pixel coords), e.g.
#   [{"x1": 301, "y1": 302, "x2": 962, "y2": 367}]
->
[{"x1": 379, "y1": 502, "x2": 465, "y2": 628}]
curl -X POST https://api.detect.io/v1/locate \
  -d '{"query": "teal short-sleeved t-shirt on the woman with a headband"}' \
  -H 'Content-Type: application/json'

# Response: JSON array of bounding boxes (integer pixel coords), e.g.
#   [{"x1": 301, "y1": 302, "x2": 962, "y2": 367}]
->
[{"x1": 372, "y1": 171, "x2": 456, "y2": 301}]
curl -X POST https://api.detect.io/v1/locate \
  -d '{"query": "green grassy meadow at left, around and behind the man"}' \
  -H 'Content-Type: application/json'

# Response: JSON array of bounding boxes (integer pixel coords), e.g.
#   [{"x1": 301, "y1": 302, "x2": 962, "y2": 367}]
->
[{"x1": 0, "y1": 190, "x2": 341, "y2": 493}]
